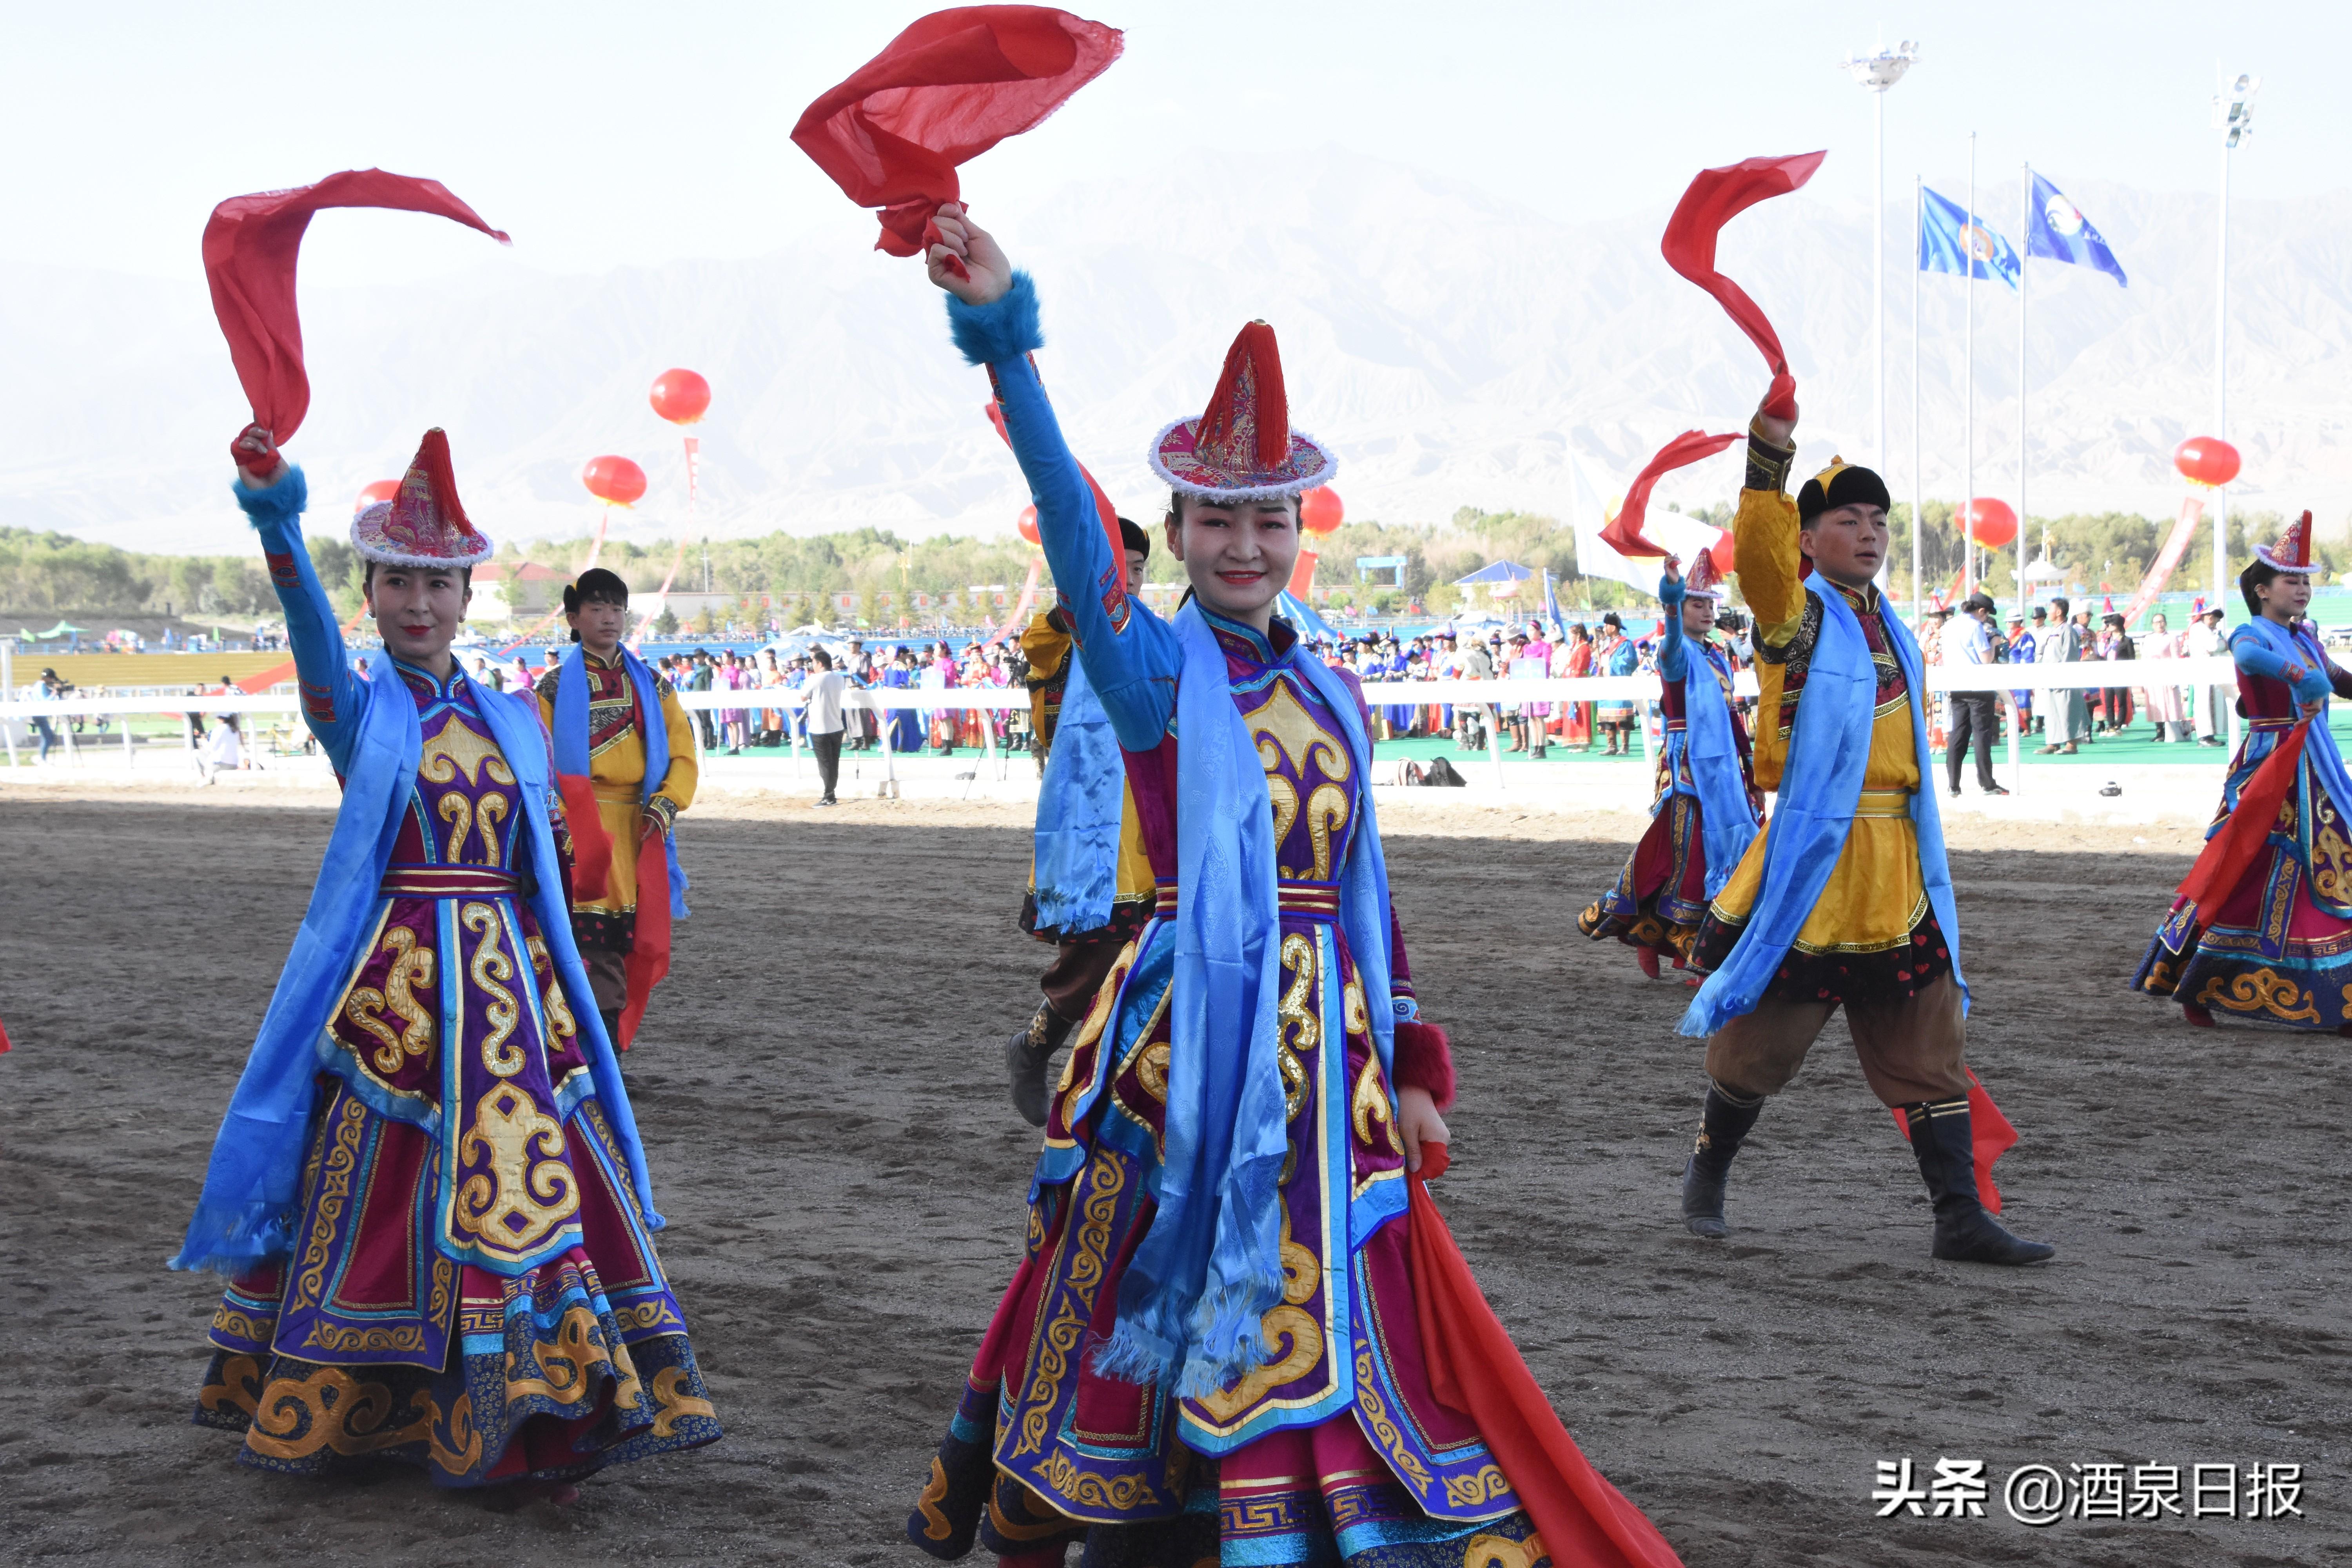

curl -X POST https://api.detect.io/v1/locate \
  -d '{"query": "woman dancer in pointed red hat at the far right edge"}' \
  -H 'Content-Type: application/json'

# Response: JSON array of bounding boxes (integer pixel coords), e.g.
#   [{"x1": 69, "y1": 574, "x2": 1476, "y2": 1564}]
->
[{"x1": 2133, "y1": 512, "x2": 2352, "y2": 1034}]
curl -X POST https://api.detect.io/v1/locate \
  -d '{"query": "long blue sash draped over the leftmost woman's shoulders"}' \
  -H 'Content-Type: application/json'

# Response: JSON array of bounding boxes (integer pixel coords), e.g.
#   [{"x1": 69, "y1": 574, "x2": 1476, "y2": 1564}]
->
[{"x1": 172, "y1": 658, "x2": 663, "y2": 1274}]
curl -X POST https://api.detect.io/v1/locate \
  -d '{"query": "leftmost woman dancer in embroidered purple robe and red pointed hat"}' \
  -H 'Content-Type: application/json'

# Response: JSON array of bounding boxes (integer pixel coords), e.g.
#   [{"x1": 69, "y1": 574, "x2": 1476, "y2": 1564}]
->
[{"x1": 172, "y1": 425, "x2": 720, "y2": 1500}]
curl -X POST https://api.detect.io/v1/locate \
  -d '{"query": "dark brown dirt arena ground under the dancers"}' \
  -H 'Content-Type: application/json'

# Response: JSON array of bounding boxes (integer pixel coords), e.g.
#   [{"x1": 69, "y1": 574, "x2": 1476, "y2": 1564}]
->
[{"x1": 0, "y1": 790, "x2": 2352, "y2": 1568}]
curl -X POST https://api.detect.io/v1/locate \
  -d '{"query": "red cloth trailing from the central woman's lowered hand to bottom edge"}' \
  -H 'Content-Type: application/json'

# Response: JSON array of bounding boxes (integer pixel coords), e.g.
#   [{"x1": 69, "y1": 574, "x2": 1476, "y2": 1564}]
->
[{"x1": 1406, "y1": 1143, "x2": 1682, "y2": 1568}]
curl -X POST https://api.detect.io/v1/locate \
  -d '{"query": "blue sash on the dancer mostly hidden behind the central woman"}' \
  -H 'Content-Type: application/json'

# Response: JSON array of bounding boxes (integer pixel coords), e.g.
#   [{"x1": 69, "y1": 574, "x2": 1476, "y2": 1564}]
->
[{"x1": 1035, "y1": 644, "x2": 1127, "y2": 936}]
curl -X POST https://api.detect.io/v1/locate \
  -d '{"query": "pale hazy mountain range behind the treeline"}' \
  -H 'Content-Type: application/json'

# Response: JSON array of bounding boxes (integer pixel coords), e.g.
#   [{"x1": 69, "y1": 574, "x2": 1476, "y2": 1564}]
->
[{"x1": 0, "y1": 151, "x2": 2352, "y2": 562}]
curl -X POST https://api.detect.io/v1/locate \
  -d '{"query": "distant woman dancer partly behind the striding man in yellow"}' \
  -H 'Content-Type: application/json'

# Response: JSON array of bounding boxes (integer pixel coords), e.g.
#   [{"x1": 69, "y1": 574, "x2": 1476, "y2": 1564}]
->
[{"x1": 1576, "y1": 550, "x2": 1764, "y2": 980}]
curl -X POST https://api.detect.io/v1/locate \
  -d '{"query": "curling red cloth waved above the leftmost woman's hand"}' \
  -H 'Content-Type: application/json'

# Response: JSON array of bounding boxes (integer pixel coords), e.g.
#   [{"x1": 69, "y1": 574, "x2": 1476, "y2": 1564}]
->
[{"x1": 205, "y1": 169, "x2": 510, "y2": 446}]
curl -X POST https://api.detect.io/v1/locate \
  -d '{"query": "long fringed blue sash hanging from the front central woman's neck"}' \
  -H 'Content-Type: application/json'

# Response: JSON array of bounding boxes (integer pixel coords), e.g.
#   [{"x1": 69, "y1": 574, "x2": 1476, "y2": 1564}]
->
[{"x1": 1096, "y1": 604, "x2": 1402, "y2": 1399}]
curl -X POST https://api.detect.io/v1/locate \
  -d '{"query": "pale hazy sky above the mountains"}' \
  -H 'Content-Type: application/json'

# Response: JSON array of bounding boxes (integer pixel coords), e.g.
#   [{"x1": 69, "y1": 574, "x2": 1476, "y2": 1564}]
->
[{"x1": 0, "y1": 0, "x2": 2352, "y2": 287}]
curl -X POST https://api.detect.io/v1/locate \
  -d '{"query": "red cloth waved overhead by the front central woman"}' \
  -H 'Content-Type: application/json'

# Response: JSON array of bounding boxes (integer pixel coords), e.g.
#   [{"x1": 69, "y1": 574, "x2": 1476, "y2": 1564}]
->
[{"x1": 793, "y1": 5, "x2": 1124, "y2": 256}]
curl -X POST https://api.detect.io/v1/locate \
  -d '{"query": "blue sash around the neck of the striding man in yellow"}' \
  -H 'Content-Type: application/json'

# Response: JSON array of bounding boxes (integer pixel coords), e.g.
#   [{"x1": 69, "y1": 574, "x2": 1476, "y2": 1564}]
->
[{"x1": 1682, "y1": 571, "x2": 1969, "y2": 1037}]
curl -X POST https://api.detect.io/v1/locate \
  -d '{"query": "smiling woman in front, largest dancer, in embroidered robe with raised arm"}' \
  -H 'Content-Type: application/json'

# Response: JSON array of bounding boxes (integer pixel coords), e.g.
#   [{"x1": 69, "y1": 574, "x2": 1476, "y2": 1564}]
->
[{"x1": 889, "y1": 205, "x2": 1675, "y2": 1568}]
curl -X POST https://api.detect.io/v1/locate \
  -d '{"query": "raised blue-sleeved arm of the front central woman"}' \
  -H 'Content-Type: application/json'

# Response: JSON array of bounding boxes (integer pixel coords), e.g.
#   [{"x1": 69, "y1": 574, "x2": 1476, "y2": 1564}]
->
[{"x1": 931, "y1": 202, "x2": 1183, "y2": 752}]
